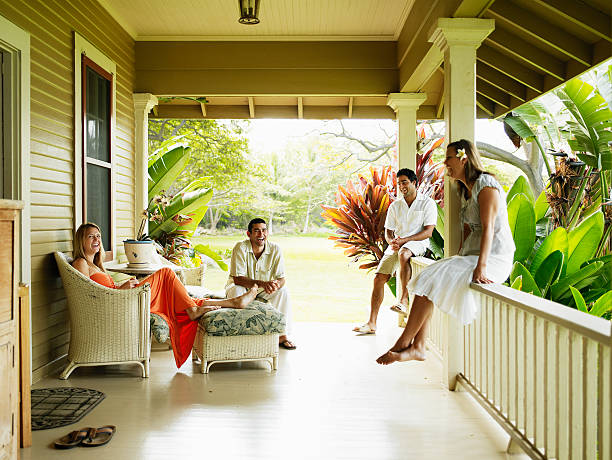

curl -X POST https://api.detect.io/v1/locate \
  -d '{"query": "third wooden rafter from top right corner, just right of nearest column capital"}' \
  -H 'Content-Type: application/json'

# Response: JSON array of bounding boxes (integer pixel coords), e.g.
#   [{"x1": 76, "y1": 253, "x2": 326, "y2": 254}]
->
[{"x1": 484, "y1": 25, "x2": 565, "y2": 82}]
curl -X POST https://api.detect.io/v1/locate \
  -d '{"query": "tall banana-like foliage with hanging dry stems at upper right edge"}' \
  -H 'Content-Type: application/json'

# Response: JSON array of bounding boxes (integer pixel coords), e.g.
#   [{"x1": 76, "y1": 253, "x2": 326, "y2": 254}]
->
[{"x1": 505, "y1": 66, "x2": 612, "y2": 255}]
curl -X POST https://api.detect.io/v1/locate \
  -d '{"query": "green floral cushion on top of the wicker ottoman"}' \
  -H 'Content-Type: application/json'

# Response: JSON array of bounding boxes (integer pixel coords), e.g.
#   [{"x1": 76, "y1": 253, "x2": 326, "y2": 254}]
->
[{"x1": 200, "y1": 300, "x2": 285, "y2": 336}]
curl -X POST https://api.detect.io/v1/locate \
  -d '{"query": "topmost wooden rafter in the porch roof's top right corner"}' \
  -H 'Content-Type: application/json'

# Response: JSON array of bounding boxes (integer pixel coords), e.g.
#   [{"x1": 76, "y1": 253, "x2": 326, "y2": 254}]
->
[{"x1": 531, "y1": 0, "x2": 612, "y2": 42}]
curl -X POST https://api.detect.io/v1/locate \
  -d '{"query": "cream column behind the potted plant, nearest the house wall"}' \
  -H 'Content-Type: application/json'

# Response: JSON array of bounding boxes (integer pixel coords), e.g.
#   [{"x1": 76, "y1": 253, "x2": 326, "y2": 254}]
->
[{"x1": 133, "y1": 93, "x2": 157, "y2": 237}]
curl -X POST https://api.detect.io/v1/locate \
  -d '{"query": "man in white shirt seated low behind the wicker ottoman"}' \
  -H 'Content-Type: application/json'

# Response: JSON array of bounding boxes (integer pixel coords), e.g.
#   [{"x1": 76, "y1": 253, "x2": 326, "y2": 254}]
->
[{"x1": 225, "y1": 218, "x2": 296, "y2": 350}]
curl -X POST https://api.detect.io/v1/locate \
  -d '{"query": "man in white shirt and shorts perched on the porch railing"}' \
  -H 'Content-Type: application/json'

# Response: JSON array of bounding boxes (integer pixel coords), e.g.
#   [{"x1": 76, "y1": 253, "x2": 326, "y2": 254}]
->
[{"x1": 353, "y1": 168, "x2": 438, "y2": 334}]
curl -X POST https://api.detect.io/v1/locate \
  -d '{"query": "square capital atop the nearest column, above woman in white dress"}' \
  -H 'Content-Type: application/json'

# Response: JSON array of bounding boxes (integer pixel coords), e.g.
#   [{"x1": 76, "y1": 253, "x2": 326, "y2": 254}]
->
[{"x1": 428, "y1": 18, "x2": 495, "y2": 51}]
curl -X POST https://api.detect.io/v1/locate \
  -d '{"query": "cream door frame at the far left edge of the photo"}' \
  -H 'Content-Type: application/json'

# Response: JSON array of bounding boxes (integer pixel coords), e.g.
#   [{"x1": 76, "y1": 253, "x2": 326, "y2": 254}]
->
[{"x1": 0, "y1": 16, "x2": 32, "y2": 284}]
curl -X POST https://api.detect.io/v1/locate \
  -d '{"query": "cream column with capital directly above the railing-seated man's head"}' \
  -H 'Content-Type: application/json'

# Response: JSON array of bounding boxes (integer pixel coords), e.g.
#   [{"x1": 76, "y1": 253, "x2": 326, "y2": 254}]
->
[{"x1": 387, "y1": 93, "x2": 427, "y2": 171}]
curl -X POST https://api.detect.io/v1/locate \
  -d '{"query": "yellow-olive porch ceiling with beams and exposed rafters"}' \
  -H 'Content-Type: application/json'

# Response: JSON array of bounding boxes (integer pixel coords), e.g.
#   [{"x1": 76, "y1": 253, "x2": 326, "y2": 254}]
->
[{"x1": 99, "y1": 0, "x2": 612, "y2": 118}]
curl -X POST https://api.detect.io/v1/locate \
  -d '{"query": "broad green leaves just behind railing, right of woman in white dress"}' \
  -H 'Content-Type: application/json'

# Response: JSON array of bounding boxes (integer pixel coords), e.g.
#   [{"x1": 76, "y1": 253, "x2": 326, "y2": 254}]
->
[{"x1": 507, "y1": 176, "x2": 612, "y2": 316}]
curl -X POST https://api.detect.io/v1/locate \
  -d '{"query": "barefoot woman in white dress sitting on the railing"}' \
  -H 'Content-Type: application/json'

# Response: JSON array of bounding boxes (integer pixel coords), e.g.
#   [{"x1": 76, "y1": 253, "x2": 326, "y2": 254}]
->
[{"x1": 376, "y1": 139, "x2": 515, "y2": 364}]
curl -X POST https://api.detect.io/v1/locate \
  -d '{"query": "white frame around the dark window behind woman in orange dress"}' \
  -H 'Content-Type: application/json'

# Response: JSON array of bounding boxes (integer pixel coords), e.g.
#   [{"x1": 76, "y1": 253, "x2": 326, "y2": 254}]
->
[{"x1": 74, "y1": 32, "x2": 118, "y2": 259}]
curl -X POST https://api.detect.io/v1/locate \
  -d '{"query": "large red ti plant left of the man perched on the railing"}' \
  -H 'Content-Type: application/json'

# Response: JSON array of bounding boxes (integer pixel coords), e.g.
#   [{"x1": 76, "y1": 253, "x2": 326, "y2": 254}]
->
[{"x1": 321, "y1": 166, "x2": 397, "y2": 269}]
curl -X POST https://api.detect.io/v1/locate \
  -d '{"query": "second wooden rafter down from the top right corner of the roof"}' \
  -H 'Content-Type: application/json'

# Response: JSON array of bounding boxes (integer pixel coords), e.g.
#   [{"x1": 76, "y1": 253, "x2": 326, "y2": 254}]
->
[{"x1": 487, "y1": 1, "x2": 592, "y2": 66}]
